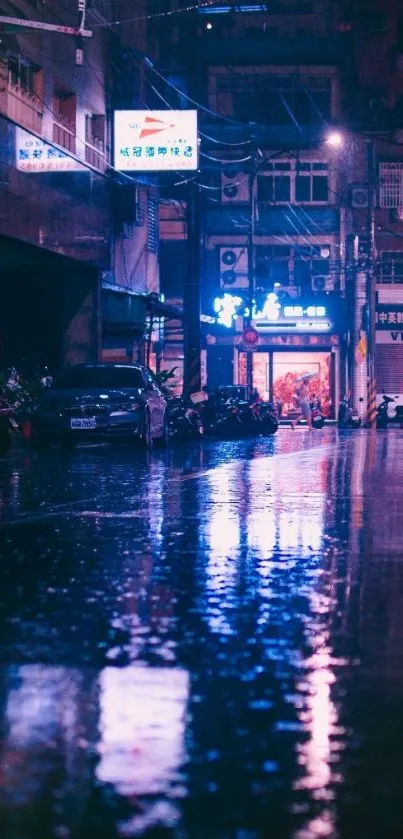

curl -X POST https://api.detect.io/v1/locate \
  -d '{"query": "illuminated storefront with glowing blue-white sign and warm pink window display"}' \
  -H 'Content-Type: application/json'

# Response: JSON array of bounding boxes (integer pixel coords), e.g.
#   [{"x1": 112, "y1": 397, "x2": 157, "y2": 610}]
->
[{"x1": 205, "y1": 293, "x2": 347, "y2": 417}]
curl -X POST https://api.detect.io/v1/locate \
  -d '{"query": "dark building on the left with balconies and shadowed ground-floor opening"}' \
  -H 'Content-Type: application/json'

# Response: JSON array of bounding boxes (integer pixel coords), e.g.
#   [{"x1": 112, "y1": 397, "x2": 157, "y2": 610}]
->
[{"x1": 0, "y1": 0, "x2": 159, "y2": 373}]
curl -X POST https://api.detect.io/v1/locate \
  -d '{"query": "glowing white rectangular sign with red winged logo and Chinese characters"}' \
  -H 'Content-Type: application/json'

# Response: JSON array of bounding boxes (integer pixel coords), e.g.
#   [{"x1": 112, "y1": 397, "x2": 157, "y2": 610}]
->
[{"x1": 114, "y1": 110, "x2": 198, "y2": 172}]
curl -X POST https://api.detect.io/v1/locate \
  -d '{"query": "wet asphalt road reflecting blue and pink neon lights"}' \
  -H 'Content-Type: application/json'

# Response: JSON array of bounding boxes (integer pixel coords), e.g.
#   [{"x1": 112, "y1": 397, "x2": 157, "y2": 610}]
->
[{"x1": 0, "y1": 429, "x2": 403, "y2": 839}]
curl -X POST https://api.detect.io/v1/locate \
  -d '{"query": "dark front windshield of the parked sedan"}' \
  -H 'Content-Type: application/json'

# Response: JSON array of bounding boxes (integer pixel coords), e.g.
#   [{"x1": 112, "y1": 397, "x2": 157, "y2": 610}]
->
[{"x1": 53, "y1": 367, "x2": 144, "y2": 390}]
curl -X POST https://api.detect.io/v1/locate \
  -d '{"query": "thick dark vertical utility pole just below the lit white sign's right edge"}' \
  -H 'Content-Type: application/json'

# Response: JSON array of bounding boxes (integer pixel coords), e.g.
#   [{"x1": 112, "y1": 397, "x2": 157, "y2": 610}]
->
[{"x1": 183, "y1": 182, "x2": 201, "y2": 395}]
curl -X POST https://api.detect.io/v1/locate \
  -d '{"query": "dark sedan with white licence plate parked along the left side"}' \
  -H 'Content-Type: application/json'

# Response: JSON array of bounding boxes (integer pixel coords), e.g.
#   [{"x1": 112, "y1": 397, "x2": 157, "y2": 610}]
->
[{"x1": 32, "y1": 364, "x2": 169, "y2": 447}]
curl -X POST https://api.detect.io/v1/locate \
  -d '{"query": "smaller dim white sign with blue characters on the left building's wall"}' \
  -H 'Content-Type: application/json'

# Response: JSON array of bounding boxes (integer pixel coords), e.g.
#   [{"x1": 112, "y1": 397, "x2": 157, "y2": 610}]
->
[{"x1": 15, "y1": 127, "x2": 85, "y2": 173}]
